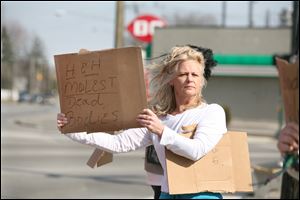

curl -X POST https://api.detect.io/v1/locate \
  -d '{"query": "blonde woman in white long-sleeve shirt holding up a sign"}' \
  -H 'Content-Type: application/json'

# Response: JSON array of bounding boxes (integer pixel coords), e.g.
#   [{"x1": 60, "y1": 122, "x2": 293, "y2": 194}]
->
[{"x1": 57, "y1": 45, "x2": 227, "y2": 199}]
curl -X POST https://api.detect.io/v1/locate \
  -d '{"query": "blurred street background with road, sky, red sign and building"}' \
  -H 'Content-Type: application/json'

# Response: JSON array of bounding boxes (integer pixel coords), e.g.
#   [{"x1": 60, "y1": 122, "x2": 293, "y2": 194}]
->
[{"x1": 1, "y1": 1, "x2": 299, "y2": 198}]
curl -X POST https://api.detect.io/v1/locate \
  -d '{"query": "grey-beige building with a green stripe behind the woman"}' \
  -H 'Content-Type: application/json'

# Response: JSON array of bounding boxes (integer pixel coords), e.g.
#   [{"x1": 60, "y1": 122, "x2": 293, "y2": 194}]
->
[{"x1": 152, "y1": 27, "x2": 291, "y2": 136}]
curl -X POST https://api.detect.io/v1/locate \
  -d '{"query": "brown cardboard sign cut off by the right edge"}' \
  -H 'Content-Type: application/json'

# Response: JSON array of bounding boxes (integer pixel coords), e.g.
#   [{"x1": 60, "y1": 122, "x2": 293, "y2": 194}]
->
[{"x1": 276, "y1": 58, "x2": 299, "y2": 123}]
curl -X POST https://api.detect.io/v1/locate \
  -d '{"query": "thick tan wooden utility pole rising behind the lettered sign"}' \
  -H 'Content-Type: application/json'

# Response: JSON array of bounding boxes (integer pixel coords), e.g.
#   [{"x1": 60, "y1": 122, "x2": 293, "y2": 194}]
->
[{"x1": 115, "y1": 1, "x2": 124, "y2": 48}]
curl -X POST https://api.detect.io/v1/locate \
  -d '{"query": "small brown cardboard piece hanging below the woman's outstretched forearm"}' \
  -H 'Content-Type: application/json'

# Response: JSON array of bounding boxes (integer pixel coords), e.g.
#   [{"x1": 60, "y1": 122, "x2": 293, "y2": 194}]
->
[{"x1": 86, "y1": 149, "x2": 113, "y2": 168}]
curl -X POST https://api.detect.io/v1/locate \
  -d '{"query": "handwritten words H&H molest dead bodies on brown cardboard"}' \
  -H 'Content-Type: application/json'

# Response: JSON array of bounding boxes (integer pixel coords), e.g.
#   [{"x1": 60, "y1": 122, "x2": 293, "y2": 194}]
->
[{"x1": 55, "y1": 52, "x2": 120, "y2": 131}]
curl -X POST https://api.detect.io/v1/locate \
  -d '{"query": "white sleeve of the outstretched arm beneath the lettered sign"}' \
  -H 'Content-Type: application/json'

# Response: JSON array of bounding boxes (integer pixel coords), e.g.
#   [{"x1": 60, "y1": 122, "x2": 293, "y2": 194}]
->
[{"x1": 65, "y1": 128, "x2": 152, "y2": 153}]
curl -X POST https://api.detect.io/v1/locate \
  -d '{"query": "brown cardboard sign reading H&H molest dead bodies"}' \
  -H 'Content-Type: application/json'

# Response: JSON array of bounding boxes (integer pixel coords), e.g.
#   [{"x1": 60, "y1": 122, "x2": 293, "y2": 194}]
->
[{"x1": 54, "y1": 47, "x2": 147, "y2": 133}]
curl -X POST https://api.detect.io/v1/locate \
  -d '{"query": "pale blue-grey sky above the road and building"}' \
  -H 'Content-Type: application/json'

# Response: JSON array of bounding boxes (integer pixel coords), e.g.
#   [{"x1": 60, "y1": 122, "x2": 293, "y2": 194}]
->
[{"x1": 1, "y1": 1, "x2": 292, "y2": 66}]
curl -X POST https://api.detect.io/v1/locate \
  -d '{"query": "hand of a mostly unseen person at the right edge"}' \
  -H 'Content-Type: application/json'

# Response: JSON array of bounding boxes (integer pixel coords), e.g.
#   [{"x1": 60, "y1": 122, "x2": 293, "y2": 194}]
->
[{"x1": 277, "y1": 122, "x2": 299, "y2": 154}]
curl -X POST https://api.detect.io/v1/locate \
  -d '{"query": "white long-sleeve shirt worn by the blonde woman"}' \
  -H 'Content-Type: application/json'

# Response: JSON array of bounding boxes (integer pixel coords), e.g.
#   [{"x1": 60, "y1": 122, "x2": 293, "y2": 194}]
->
[{"x1": 66, "y1": 104, "x2": 227, "y2": 193}]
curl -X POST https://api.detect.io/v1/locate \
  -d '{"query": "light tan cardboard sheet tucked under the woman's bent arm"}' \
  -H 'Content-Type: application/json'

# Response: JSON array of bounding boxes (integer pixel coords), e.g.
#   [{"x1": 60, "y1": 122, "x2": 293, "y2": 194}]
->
[{"x1": 166, "y1": 132, "x2": 253, "y2": 194}]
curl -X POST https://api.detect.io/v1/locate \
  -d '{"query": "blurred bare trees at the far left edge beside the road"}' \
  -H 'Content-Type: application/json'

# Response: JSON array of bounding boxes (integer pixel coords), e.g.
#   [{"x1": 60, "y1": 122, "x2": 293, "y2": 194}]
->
[{"x1": 1, "y1": 21, "x2": 49, "y2": 93}]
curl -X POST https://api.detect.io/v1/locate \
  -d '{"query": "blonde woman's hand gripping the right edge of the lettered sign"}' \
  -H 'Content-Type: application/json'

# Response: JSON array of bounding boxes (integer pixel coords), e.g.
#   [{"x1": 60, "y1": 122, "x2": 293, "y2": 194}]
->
[{"x1": 137, "y1": 109, "x2": 164, "y2": 136}]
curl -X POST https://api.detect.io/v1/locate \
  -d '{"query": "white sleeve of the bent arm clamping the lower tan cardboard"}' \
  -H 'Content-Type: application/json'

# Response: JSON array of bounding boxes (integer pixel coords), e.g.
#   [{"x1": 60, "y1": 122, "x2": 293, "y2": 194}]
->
[{"x1": 160, "y1": 104, "x2": 227, "y2": 161}]
